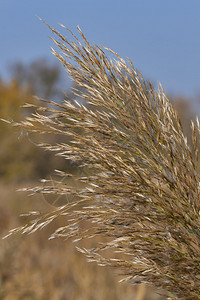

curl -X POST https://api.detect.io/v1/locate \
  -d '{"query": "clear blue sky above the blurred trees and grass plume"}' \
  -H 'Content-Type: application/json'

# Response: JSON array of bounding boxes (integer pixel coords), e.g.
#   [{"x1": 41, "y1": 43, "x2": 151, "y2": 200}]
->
[{"x1": 0, "y1": 0, "x2": 200, "y2": 98}]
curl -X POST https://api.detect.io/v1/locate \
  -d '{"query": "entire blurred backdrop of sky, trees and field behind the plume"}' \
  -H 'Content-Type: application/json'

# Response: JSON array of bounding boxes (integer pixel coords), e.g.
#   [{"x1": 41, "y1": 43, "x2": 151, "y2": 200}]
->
[{"x1": 0, "y1": 0, "x2": 200, "y2": 300}]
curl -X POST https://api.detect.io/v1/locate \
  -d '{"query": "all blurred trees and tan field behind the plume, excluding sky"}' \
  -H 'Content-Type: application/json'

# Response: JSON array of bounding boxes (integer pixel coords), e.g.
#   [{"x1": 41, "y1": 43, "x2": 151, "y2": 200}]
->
[{"x1": 0, "y1": 61, "x2": 197, "y2": 300}]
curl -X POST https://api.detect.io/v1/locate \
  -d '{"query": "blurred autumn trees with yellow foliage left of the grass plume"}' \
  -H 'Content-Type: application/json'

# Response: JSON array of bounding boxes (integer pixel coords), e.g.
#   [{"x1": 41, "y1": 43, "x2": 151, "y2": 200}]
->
[{"x1": 0, "y1": 60, "x2": 76, "y2": 183}]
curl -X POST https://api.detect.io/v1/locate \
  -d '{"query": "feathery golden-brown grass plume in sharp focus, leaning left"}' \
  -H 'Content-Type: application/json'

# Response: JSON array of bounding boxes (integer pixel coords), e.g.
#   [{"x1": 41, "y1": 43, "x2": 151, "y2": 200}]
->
[{"x1": 7, "y1": 25, "x2": 200, "y2": 300}]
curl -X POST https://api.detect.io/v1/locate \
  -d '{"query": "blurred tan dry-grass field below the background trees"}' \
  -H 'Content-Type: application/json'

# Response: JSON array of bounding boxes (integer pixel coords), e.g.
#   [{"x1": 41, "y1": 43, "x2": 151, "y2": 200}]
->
[{"x1": 0, "y1": 185, "x2": 165, "y2": 300}]
